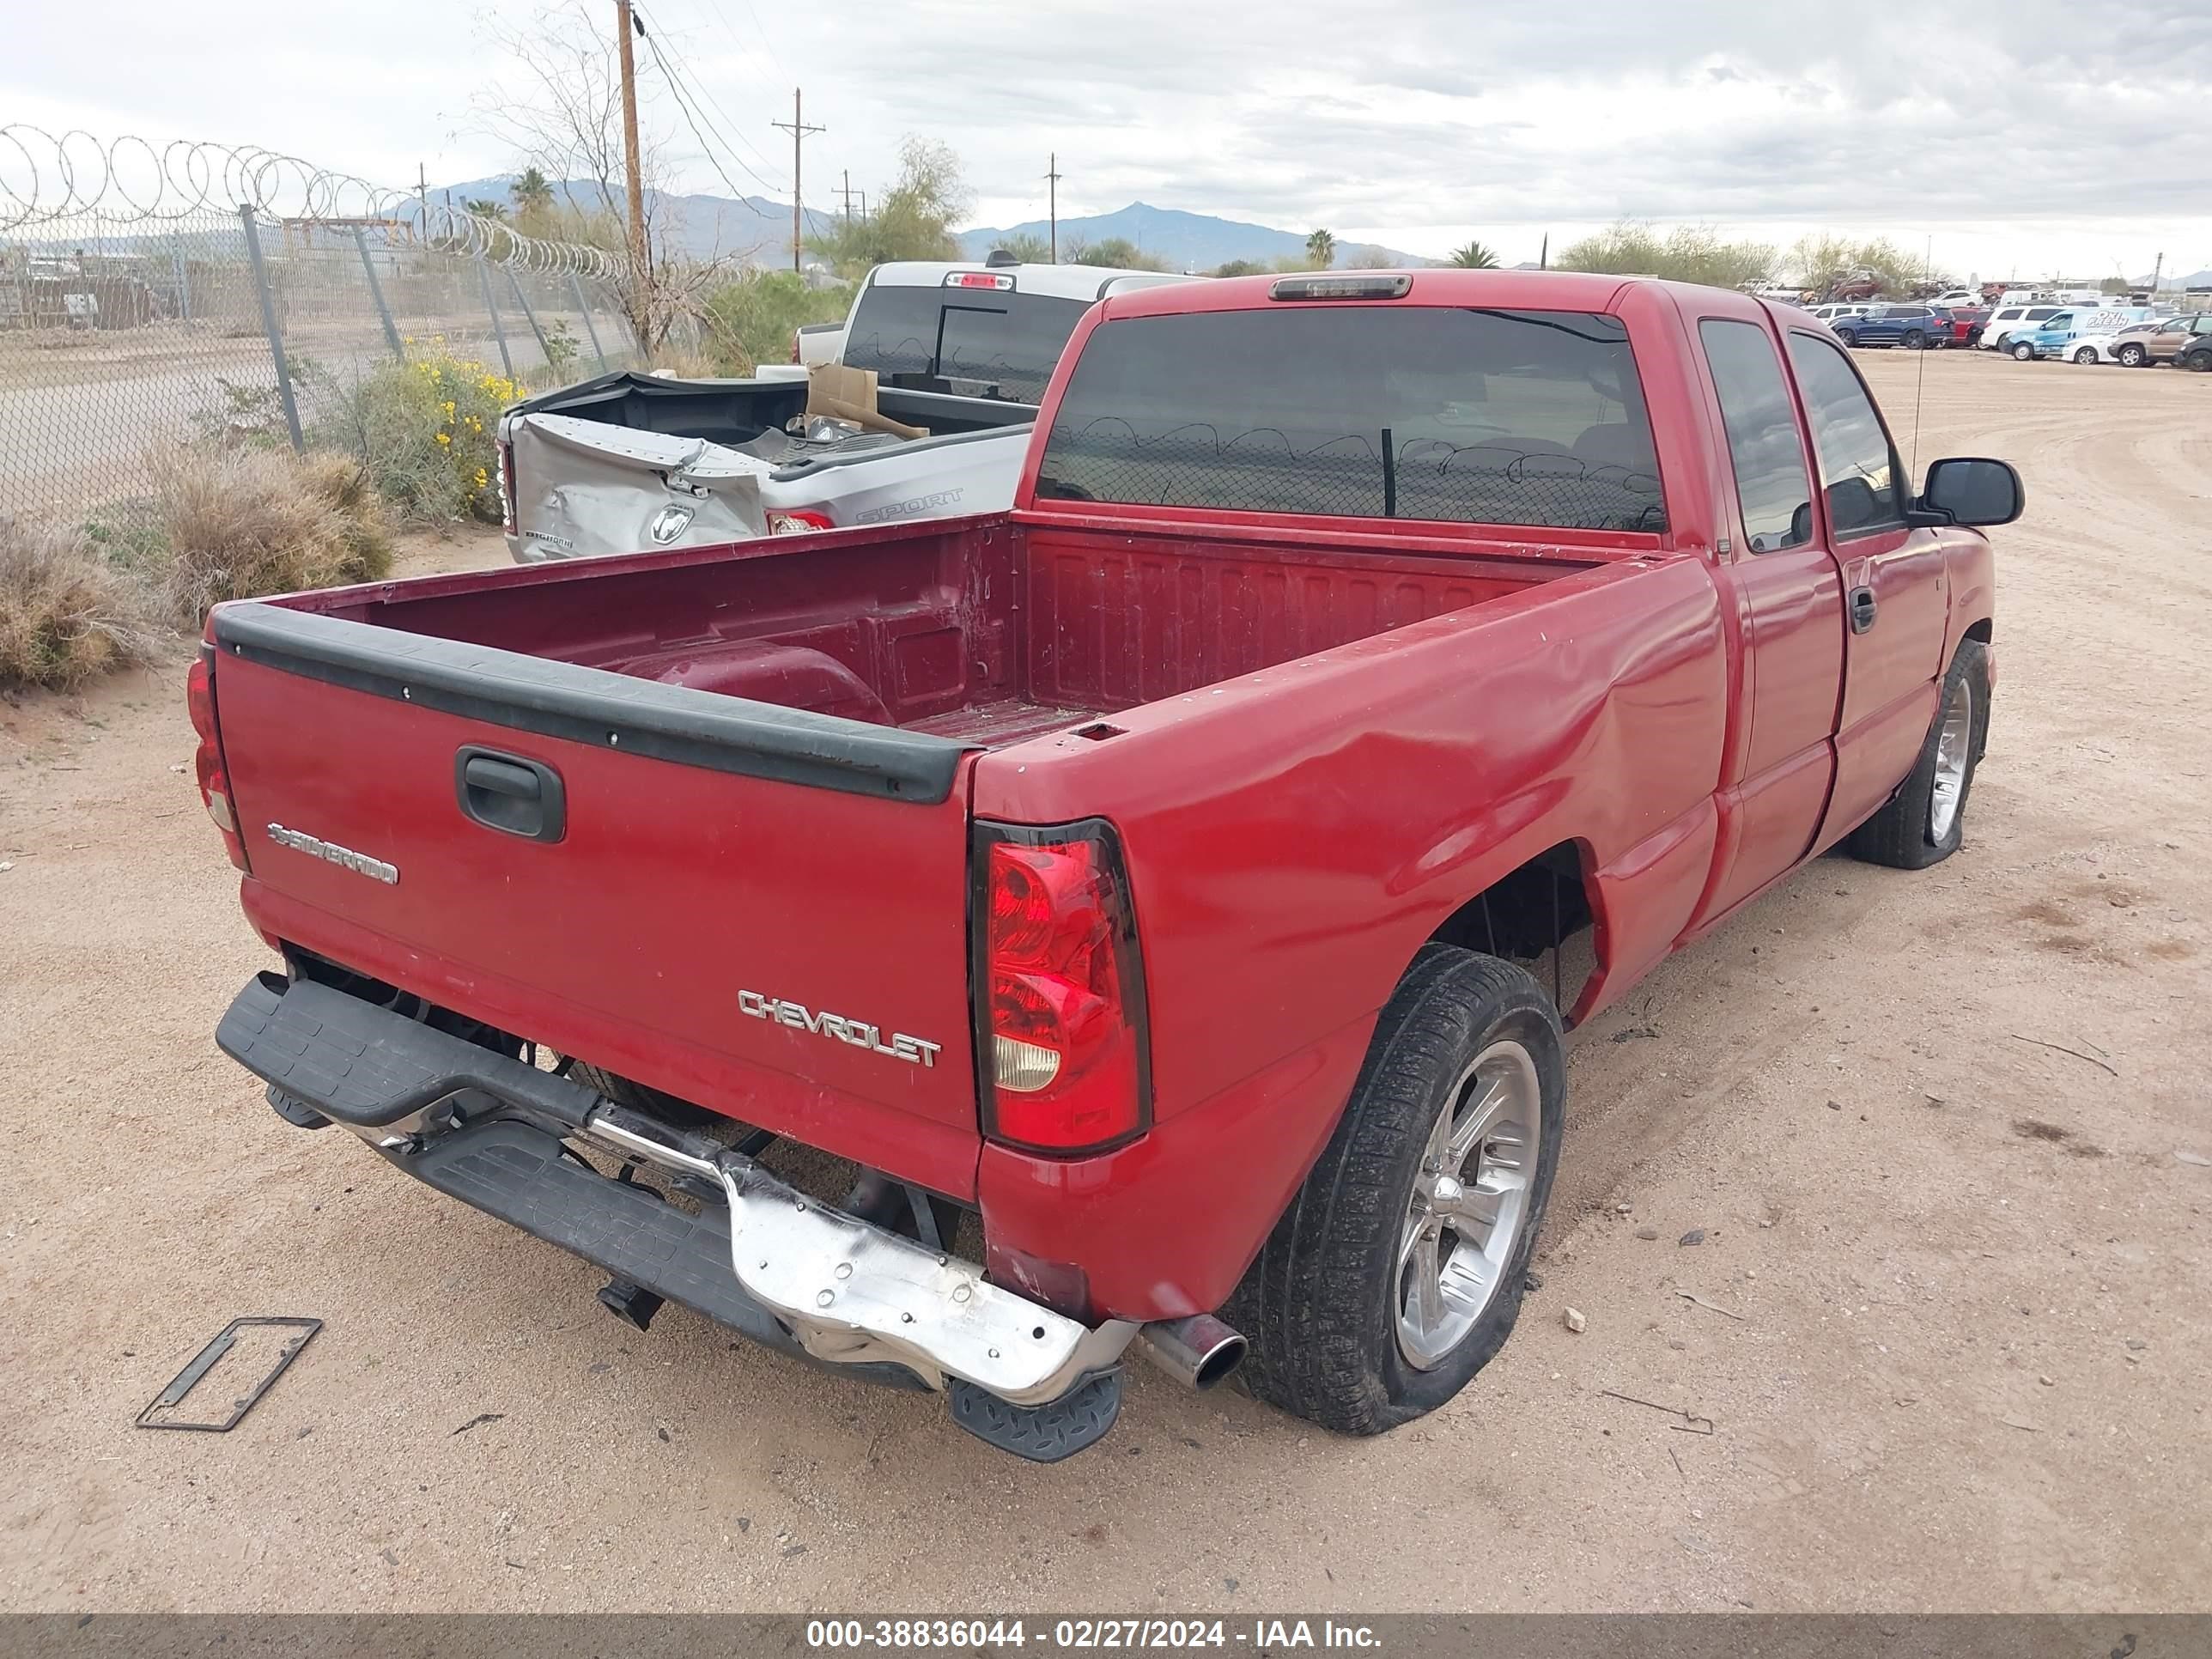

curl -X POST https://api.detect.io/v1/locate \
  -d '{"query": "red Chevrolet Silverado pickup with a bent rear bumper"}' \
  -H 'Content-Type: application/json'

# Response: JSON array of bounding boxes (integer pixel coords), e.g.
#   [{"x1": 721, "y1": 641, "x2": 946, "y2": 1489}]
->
[{"x1": 191, "y1": 270, "x2": 2021, "y2": 1460}]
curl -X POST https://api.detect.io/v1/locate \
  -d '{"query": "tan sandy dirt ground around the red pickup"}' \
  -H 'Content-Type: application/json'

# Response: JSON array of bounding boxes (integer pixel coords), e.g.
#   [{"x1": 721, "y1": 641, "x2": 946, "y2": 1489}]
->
[{"x1": 0, "y1": 352, "x2": 2212, "y2": 1613}]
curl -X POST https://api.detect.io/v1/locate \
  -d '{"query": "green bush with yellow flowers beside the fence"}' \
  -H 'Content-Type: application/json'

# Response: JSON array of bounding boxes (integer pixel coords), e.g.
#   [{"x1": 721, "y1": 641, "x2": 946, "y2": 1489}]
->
[{"x1": 312, "y1": 343, "x2": 529, "y2": 522}]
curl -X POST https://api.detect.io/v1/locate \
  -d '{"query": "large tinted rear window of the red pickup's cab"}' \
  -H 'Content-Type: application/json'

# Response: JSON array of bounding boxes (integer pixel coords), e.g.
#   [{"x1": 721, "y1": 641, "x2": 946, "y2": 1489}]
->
[{"x1": 1037, "y1": 303, "x2": 1666, "y2": 533}]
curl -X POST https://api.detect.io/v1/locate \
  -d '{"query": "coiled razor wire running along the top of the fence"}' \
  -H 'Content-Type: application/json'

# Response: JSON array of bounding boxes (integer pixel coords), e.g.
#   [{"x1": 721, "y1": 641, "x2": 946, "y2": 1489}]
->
[{"x1": 0, "y1": 122, "x2": 622, "y2": 281}]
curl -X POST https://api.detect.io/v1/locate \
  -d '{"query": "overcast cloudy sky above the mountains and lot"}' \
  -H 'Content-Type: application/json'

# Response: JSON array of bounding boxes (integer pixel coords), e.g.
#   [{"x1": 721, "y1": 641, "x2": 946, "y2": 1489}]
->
[{"x1": 0, "y1": 0, "x2": 2212, "y2": 276}]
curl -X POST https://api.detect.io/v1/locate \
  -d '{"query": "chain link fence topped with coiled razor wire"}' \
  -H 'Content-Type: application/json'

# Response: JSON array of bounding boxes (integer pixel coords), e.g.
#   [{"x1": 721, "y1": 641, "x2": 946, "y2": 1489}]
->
[{"x1": 0, "y1": 128, "x2": 637, "y2": 531}]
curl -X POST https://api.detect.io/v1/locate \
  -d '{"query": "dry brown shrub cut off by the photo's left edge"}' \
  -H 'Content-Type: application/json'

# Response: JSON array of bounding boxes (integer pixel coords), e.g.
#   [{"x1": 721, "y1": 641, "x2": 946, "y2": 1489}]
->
[{"x1": 0, "y1": 515, "x2": 157, "y2": 690}]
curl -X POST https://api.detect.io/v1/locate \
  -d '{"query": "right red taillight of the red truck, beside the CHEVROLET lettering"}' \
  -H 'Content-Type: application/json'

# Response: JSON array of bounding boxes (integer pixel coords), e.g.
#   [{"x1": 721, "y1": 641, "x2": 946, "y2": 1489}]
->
[{"x1": 975, "y1": 818, "x2": 1152, "y2": 1152}]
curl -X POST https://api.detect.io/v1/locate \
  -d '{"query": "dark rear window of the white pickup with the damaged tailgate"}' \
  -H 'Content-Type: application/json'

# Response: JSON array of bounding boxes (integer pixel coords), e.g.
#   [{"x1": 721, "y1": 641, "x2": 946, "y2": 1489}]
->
[{"x1": 845, "y1": 283, "x2": 1091, "y2": 403}]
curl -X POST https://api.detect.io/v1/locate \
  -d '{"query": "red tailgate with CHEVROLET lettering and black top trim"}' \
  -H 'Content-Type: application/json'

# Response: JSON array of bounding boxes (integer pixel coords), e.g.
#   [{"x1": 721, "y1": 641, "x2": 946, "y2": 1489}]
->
[{"x1": 212, "y1": 604, "x2": 978, "y2": 1197}]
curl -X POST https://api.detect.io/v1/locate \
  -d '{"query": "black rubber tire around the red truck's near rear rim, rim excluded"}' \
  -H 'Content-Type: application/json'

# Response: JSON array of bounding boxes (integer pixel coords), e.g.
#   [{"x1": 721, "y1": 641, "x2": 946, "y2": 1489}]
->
[{"x1": 1224, "y1": 945, "x2": 1566, "y2": 1433}]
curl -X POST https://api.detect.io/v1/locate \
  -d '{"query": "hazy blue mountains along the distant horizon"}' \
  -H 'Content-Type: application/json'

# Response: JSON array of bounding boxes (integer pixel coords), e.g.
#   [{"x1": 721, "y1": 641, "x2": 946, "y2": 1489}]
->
[{"x1": 431, "y1": 175, "x2": 1429, "y2": 270}]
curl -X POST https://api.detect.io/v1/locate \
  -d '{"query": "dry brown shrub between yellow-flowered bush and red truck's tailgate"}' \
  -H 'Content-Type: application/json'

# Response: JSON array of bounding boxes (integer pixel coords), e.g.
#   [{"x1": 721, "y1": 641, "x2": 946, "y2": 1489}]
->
[{"x1": 153, "y1": 449, "x2": 392, "y2": 629}]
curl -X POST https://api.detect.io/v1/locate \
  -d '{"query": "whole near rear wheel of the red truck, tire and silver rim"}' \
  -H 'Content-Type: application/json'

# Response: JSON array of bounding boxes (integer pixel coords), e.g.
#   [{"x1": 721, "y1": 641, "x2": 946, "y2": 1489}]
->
[{"x1": 1225, "y1": 945, "x2": 1566, "y2": 1433}]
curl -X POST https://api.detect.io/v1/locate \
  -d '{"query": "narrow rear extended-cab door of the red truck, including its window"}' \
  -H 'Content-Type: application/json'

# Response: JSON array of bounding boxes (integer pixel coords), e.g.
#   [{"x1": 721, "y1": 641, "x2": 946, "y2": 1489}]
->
[{"x1": 1692, "y1": 309, "x2": 1843, "y2": 927}]
